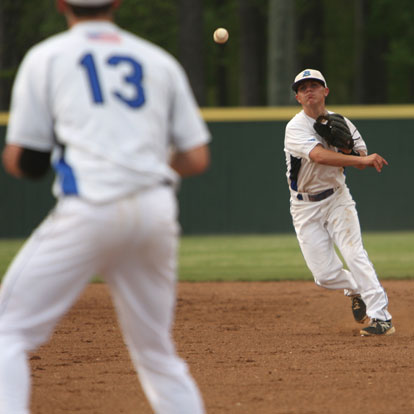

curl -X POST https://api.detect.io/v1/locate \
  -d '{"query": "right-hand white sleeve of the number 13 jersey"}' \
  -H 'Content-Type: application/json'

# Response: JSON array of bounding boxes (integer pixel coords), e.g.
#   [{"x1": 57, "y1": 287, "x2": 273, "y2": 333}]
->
[{"x1": 170, "y1": 63, "x2": 210, "y2": 152}]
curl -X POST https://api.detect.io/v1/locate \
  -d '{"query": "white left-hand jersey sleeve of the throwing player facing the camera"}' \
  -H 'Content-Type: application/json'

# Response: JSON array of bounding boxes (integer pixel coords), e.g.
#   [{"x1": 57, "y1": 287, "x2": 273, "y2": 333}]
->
[{"x1": 285, "y1": 122, "x2": 321, "y2": 161}]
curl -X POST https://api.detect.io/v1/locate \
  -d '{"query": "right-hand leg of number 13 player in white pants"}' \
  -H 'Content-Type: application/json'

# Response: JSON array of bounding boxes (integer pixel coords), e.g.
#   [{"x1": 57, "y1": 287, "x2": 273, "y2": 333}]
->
[{"x1": 105, "y1": 188, "x2": 204, "y2": 414}]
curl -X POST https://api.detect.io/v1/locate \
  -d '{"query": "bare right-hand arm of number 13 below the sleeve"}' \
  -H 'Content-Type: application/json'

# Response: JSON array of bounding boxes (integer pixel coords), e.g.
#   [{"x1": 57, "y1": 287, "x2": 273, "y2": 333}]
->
[{"x1": 170, "y1": 145, "x2": 210, "y2": 177}]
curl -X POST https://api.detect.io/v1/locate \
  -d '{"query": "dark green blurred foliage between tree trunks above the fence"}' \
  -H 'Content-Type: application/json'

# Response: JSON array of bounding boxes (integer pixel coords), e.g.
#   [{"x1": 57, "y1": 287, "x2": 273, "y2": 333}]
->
[{"x1": 0, "y1": 0, "x2": 414, "y2": 110}]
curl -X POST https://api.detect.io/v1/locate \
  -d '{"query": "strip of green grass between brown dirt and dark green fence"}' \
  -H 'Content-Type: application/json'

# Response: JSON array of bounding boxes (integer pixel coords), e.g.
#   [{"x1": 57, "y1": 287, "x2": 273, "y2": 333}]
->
[{"x1": 0, "y1": 232, "x2": 414, "y2": 281}]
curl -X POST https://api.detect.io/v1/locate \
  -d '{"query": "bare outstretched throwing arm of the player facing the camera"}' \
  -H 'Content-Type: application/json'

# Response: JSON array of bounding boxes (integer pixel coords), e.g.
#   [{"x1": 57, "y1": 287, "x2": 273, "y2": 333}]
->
[{"x1": 309, "y1": 145, "x2": 388, "y2": 172}]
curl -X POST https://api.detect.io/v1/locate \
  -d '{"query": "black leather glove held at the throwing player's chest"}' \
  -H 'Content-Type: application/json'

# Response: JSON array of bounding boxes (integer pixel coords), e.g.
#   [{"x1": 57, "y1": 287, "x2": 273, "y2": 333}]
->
[{"x1": 313, "y1": 114, "x2": 354, "y2": 150}]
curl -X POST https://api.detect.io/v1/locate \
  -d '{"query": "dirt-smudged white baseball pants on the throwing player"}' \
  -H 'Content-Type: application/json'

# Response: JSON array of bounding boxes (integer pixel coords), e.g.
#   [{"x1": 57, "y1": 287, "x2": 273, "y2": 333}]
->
[{"x1": 291, "y1": 186, "x2": 391, "y2": 320}]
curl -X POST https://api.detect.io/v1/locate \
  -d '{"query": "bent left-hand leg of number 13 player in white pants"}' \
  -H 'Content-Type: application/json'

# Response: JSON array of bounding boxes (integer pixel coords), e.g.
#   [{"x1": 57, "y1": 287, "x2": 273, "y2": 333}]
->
[{"x1": 0, "y1": 198, "x2": 104, "y2": 414}]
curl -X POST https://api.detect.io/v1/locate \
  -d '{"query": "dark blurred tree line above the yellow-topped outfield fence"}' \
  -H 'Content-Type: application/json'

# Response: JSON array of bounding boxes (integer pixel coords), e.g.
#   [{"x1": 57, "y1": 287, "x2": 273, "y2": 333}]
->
[{"x1": 0, "y1": 0, "x2": 414, "y2": 111}]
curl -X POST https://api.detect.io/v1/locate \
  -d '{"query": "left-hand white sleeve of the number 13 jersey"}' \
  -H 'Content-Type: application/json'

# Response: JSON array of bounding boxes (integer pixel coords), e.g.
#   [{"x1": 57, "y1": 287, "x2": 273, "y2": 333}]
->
[{"x1": 6, "y1": 48, "x2": 53, "y2": 151}]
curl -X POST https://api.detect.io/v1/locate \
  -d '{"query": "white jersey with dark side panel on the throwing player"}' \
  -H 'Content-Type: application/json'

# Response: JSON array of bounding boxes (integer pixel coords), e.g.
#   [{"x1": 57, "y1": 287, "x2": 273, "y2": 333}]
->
[{"x1": 285, "y1": 110, "x2": 367, "y2": 200}]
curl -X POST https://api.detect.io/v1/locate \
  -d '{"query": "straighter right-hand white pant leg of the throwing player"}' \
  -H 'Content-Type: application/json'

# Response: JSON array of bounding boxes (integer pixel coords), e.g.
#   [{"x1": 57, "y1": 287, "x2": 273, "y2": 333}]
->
[{"x1": 327, "y1": 189, "x2": 391, "y2": 320}]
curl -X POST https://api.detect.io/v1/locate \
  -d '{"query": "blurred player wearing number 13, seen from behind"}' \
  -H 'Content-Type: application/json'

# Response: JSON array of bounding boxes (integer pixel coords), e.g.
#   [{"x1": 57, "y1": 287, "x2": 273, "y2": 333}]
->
[{"x1": 0, "y1": 0, "x2": 210, "y2": 414}]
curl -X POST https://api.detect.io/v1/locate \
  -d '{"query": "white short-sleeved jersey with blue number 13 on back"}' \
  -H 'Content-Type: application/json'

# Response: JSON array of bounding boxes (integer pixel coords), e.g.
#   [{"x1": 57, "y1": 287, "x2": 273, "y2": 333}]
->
[{"x1": 7, "y1": 21, "x2": 209, "y2": 202}]
